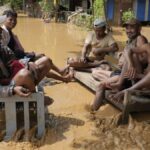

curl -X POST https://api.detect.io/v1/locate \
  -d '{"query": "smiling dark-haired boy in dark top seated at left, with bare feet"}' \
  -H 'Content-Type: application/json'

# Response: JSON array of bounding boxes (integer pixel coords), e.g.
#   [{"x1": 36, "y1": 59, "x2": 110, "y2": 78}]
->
[{"x1": 2, "y1": 10, "x2": 72, "y2": 82}]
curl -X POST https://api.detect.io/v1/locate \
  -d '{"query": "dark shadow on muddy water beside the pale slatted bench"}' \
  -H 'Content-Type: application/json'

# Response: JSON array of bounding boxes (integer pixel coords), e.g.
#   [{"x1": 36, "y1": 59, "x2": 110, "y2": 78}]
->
[{"x1": 44, "y1": 114, "x2": 85, "y2": 145}]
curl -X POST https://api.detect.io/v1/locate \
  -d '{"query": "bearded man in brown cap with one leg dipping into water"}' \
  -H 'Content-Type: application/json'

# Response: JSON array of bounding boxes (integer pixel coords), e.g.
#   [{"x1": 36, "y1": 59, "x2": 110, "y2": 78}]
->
[{"x1": 91, "y1": 19, "x2": 147, "y2": 111}]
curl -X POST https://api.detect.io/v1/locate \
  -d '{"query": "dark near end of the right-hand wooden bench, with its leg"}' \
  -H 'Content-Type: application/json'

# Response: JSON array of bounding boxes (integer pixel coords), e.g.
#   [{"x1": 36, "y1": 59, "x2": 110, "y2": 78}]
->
[{"x1": 105, "y1": 90, "x2": 150, "y2": 124}]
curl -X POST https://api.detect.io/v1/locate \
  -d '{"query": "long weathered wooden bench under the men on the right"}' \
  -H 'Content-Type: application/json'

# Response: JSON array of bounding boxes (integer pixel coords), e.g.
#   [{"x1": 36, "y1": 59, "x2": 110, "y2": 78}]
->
[{"x1": 75, "y1": 71, "x2": 150, "y2": 124}]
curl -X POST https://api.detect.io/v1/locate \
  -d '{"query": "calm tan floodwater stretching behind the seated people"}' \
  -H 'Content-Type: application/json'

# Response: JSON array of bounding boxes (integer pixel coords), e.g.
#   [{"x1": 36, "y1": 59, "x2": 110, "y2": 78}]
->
[{"x1": 15, "y1": 18, "x2": 86, "y2": 66}]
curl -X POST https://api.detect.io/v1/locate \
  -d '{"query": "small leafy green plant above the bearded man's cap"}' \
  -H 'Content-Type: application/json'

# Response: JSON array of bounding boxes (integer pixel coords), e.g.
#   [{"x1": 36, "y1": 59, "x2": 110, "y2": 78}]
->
[{"x1": 122, "y1": 9, "x2": 135, "y2": 23}]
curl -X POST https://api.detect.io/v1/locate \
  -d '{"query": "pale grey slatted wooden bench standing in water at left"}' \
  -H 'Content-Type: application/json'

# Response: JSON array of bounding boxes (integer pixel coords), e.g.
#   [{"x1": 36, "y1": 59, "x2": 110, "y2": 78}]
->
[{"x1": 0, "y1": 87, "x2": 45, "y2": 140}]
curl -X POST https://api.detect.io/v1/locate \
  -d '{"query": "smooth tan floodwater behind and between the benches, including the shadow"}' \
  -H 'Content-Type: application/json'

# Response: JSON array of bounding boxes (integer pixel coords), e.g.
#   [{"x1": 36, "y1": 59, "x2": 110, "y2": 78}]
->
[{"x1": 14, "y1": 18, "x2": 98, "y2": 150}]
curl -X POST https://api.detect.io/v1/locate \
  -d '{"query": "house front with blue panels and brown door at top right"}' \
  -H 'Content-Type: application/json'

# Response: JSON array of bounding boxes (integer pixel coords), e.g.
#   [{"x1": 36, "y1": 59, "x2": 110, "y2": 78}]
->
[{"x1": 106, "y1": 0, "x2": 150, "y2": 24}]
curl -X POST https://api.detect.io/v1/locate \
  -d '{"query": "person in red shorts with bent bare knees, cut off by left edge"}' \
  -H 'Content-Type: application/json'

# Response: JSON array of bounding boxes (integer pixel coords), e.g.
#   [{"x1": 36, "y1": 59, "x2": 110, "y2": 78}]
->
[{"x1": 0, "y1": 19, "x2": 73, "y2": 96}]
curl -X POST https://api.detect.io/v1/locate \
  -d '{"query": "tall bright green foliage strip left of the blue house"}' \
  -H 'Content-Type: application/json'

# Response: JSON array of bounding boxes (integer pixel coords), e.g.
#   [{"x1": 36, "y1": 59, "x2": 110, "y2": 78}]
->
[{"x1": 93, "y1": 0, "x2": 104, "y2": 19}]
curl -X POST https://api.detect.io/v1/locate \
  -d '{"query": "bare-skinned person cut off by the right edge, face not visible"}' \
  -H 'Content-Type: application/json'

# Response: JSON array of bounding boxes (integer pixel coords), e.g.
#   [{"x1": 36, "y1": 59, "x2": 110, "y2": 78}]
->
[{"x1": 112, "y1": 43, "x2": 150, "y2": 102}]
